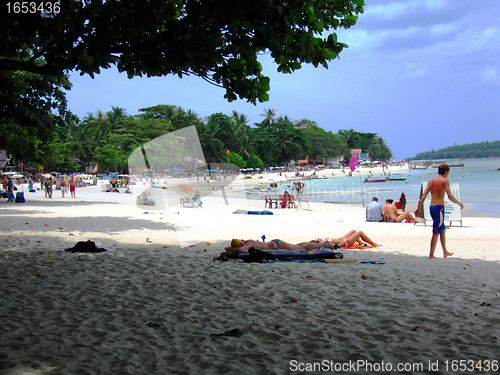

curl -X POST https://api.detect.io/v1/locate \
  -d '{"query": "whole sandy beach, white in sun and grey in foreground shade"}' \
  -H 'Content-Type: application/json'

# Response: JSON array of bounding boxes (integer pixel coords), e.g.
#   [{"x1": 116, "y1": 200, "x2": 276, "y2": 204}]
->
[{"x1": 0, "y1": 171, "x2": 500, "y2": 375}]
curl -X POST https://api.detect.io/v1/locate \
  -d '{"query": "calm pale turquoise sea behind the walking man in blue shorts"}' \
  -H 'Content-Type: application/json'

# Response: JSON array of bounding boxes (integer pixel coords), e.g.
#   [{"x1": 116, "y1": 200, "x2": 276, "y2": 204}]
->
[{"x1": 281, "y1": 158, "x2": 500, "y2": 217}]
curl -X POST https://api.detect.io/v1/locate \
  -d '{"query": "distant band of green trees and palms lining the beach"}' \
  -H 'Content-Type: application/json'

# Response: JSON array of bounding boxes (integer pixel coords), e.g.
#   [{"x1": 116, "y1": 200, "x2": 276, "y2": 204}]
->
[{"x1": 4, "y1": 105, "x2": 390, "y2": 173}]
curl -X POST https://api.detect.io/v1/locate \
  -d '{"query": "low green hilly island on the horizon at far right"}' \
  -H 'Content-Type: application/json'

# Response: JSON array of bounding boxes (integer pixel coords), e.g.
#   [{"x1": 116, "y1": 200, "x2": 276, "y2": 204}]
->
[{"x1": 406, "y1": 140, "x2": 500, "y2": 161}]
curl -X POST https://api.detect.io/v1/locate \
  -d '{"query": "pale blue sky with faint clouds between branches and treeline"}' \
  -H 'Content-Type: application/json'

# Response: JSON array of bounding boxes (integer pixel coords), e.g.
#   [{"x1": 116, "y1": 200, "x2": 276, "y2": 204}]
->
[{"x1": 67, "y1": 0, "x2": 500, "y2": 159}]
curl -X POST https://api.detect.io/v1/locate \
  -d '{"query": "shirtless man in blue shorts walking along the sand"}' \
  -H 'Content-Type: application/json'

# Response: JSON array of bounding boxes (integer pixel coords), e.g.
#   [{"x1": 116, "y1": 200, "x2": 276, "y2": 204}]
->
[{"x1": 415, "y1": 164, "x2": 464, "y2": 258}]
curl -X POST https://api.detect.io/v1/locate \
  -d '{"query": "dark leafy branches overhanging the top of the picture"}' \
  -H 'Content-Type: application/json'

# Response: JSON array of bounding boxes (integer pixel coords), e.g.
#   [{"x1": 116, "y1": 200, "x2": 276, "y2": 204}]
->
[{"x1": 0, "y1": 0, "x2": 364, "y2": 103}]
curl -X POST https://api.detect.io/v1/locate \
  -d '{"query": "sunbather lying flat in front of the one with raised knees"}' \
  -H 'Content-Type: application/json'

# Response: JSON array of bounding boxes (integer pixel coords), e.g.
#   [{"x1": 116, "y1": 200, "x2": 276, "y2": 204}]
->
[{"x1": 221, "y1": 238, "x2": 335, "y2": 256}]
